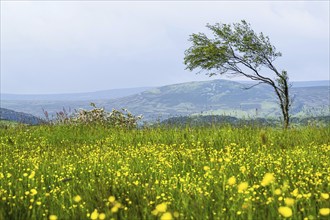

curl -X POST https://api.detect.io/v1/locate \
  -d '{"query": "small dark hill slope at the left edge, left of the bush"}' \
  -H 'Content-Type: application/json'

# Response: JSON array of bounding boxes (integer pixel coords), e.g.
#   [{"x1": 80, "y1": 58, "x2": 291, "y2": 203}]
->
[{"x1": 0, "y1": 108, "x2": 43, "y2": 125}]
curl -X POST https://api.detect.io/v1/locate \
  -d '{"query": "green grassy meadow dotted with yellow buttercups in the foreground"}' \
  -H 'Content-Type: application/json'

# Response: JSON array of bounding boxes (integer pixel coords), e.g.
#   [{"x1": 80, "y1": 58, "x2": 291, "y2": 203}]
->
[{"x1": 0, "y1": 125, "x2": 330, "y2": 220}]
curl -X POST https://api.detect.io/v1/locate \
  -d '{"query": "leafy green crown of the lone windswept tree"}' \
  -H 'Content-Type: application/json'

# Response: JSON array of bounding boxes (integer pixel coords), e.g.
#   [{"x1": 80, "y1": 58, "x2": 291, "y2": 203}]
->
[{"x1": 184, "y1": 20, "x2": 281, "y2": 76}]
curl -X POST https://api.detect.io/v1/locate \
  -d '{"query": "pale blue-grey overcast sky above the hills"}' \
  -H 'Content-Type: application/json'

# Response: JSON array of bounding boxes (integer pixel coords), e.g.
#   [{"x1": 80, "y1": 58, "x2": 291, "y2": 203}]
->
[{"x1": 0, "y1": 0, "x2": 330, "y2": 94}]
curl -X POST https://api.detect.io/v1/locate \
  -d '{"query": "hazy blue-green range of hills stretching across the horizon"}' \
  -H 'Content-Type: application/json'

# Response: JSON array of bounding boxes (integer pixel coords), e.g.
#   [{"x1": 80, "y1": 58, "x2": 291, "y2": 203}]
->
[{"x1": 1, "y1": 80, "x2": 330, "y2": 120}]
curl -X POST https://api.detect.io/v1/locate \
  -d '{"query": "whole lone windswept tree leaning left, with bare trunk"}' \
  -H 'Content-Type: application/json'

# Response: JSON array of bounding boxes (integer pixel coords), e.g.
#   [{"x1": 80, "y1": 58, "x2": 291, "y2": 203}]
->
[{"x1": 184, "y1": 20, "x2": 291, "y2": 128}]
